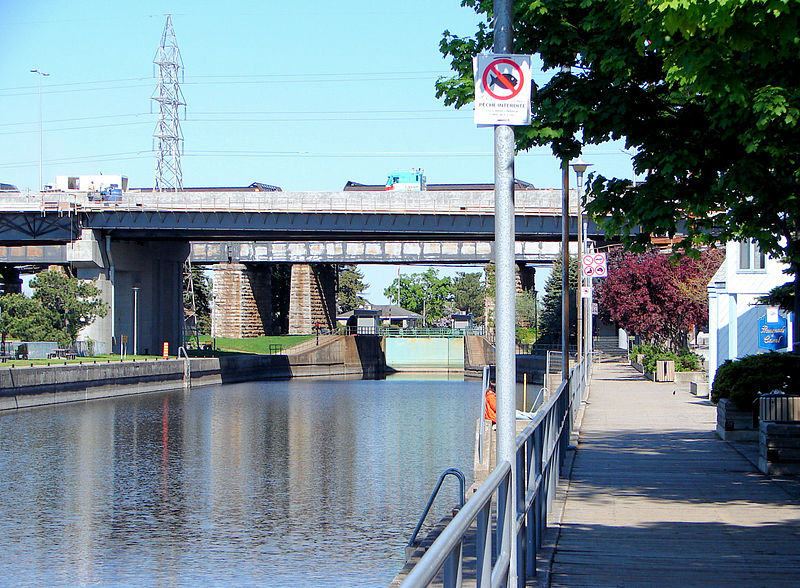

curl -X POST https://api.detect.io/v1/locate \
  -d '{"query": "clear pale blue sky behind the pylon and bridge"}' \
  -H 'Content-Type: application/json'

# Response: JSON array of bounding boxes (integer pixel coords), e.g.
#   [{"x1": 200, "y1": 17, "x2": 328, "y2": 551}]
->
[{"x1": 0, "y1": 0, "x2": 630, "y2": 302}]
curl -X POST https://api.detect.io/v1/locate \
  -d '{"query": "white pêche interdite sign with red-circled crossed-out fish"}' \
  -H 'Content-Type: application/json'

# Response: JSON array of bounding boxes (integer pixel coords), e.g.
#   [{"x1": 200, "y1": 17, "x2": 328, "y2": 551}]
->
[{"x1": 472, "y1": 53, "x2": 531, "y2": 125}]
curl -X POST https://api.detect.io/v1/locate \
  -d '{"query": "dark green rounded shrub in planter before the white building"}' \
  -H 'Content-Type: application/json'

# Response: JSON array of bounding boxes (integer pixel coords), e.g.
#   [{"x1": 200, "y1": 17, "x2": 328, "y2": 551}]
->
[{"x1": 711, "y1": 353, "x2": 800, "y2": 410}]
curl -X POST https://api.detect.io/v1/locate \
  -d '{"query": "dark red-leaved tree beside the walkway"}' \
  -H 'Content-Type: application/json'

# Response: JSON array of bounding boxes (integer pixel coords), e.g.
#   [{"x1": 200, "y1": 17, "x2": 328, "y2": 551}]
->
[{"x1": 595, "y1": 249, "x2": 724, "y2": 351}]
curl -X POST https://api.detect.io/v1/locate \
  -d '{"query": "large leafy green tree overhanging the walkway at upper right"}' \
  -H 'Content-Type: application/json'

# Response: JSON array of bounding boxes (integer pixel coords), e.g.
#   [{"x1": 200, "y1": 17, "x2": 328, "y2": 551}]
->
[{"x1": 437, "y1": 0, "x2": 800, "y2": 346}]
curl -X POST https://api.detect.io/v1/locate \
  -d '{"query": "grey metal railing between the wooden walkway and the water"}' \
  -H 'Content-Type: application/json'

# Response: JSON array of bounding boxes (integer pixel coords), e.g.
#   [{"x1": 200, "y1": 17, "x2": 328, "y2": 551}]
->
[{"x1": 401, "y1": 362, "x2": 587, "y2": 588}]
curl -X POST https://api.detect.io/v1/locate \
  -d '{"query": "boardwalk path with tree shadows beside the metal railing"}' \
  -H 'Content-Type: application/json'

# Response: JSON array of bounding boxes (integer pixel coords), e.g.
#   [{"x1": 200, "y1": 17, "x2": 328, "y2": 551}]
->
[{"x1": 552, "y1": 364, "x2": 800, "y2": 587}]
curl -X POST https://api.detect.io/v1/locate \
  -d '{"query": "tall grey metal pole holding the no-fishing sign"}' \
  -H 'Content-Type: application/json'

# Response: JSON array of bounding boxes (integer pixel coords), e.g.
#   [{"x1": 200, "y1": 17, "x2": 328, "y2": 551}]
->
[{"x1": 494, "y1": 0, "x2": 517, "y2": 586}]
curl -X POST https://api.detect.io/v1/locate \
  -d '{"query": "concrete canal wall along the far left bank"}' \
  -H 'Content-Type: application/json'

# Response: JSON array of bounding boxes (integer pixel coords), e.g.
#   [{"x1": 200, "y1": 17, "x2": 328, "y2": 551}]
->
[{"x1": 0, "y1": 336, "x2": 386, "y2": 410}]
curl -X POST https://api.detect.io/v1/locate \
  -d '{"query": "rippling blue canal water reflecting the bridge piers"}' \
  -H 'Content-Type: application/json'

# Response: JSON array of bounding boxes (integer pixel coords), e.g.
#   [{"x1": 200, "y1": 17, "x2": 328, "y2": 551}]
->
[{"x1": 0, "y1": 375, "x2": 481, "y2": 588}]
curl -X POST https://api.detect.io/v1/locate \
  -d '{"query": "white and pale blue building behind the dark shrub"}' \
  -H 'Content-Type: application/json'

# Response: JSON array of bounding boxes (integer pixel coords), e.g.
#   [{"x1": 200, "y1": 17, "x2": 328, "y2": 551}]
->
[{"x1": 708, "y1": 241, "x2": 792, "y2": 383}]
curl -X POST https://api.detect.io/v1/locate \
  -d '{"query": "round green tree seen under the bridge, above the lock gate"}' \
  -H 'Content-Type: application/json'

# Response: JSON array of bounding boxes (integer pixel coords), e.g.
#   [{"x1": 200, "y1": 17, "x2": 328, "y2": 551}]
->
[{"x1": 383, "y1": 268, "x2": 453, "y2": 325}]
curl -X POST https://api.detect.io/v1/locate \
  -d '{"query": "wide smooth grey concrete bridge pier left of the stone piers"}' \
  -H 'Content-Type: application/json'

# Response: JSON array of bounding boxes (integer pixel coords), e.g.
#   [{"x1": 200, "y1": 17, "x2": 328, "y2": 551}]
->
[{"x1": 71, "y1": 239, "x2": 189, "y2": 355}]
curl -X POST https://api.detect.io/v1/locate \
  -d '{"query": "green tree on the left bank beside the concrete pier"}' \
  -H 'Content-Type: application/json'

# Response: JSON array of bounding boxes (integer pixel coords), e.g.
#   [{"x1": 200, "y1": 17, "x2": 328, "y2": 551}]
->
[{"x1": 0, "y1": 270, "x2": 108, "y2": 347}]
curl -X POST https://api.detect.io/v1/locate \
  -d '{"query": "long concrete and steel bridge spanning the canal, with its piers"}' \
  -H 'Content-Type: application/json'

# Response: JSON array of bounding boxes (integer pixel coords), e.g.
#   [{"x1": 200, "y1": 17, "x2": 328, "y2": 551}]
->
[{"x1": 0, "y1": 189, "x2": 600, "y2": 352}]
